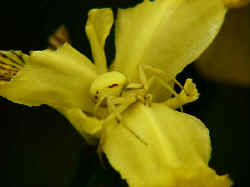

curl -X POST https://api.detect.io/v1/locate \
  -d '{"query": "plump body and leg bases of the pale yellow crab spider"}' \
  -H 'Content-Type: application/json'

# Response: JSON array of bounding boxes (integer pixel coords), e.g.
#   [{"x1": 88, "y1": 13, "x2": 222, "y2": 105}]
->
[{"x1": 90, "y1": 67, "x2": 152, "y2": 117}]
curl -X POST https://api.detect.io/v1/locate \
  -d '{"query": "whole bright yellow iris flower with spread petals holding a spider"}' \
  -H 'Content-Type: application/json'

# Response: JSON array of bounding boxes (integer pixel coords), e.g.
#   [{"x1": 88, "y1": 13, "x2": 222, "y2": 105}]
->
[{"x1": 0, "y1": 0, "x2": 232, "y2": 187}]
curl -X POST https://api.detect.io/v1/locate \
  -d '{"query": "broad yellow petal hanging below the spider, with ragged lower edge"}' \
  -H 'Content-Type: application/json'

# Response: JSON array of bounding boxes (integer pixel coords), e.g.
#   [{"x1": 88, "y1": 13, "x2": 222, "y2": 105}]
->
[{"x1": 103, "y1": 103, "x2": 231, "y2": 187}]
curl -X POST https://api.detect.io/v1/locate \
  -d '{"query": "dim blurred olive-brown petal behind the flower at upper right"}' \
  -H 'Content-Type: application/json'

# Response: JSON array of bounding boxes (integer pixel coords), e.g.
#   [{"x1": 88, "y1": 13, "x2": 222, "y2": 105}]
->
[{"x1": 194, "y1": 6, "x2": 250, "y2": 87}]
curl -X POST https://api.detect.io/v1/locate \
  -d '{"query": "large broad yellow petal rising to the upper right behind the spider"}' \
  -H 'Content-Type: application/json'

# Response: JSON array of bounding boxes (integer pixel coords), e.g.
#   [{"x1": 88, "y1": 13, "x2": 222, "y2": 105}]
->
[{"x1": 112, "y1": 0, "x2": 226, "y2": 80}]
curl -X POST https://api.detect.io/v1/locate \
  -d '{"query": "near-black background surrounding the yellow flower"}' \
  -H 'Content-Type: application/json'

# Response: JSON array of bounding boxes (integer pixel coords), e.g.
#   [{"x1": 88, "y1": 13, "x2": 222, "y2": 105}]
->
[{"x1": 0, "y1": 0, "x2": 250, "y2": 187}]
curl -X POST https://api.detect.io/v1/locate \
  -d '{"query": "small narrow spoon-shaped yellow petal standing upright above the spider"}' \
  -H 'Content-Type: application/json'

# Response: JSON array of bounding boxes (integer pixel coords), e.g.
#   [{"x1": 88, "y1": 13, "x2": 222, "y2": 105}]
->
[{"x1": 85, "y1": 8, "x2": 113, "y2": 74}]
